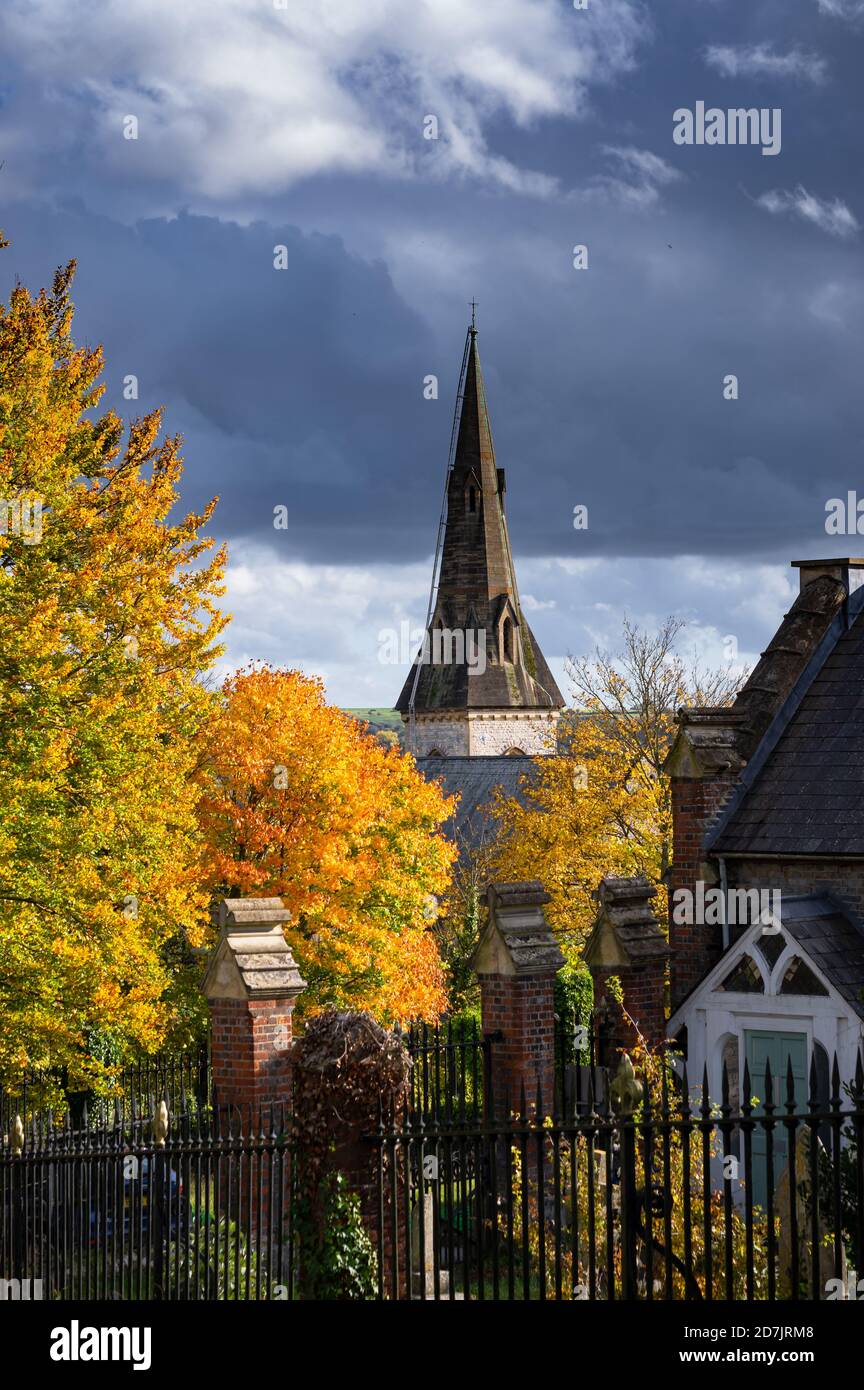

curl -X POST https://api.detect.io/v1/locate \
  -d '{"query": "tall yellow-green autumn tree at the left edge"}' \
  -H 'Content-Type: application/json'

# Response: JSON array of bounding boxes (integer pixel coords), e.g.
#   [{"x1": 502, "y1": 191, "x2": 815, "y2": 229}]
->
[{"x1": 0, "y1": 255, "x2": 225, "y2": 1087}]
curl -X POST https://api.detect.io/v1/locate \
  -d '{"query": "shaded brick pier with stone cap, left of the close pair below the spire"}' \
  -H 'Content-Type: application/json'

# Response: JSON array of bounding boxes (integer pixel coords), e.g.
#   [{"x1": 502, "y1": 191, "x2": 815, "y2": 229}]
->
[{"x1": 474, "y1": 881, "x2": 564, "y2": 1115}]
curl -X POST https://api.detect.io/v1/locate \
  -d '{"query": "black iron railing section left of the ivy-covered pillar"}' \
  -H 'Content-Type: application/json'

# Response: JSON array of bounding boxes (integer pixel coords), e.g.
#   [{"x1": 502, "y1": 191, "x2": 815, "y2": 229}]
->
[{"x1": 0, "y1": 1106, "x2": 294, "y2": 1300}]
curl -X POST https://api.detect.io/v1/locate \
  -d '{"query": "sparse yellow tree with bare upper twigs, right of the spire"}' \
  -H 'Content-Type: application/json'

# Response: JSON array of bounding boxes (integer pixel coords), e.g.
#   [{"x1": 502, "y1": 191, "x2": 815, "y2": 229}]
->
[{"x1": 493, "y1": 617, "x2": 743, "y2": 951}]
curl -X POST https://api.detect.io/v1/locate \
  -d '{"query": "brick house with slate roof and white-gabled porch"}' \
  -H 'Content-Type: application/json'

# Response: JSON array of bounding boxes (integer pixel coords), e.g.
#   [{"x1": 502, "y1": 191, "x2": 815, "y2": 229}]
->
[{"x1": 667, "y1": 559, "x2": 864, "y2": 1173}]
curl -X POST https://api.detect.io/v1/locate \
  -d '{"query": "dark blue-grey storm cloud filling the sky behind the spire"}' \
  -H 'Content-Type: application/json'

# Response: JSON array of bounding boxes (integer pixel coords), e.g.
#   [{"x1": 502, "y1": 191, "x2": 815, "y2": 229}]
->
[{"x1": 0, "y1": 0, "x2": 864, "y2": 575}]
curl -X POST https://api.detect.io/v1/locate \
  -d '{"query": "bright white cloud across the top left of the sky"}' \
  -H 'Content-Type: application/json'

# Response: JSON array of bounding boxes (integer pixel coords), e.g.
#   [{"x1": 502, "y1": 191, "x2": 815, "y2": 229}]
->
[{"x1": 0, "y1": 0, "x2": 646, "y2": 199}]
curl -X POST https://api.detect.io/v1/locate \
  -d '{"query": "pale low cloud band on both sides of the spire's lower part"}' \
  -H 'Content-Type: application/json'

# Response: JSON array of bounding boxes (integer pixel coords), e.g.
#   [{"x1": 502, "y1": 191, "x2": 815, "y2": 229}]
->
[{"x1": 221, "y1": 542, "x2": 796, "y2": 708}]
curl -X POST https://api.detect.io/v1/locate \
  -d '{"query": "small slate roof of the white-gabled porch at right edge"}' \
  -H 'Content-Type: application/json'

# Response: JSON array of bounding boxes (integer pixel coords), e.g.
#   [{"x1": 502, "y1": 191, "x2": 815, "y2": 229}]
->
[{"x1": 779, "y1": 892, "x2": 864, "y2": 1017}]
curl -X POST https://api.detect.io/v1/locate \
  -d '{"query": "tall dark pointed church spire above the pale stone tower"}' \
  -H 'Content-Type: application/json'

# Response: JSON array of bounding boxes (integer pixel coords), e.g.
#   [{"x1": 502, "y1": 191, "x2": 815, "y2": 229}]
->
[{"x1": 396, "y1": 327, "x2": 565, "y2": 713}]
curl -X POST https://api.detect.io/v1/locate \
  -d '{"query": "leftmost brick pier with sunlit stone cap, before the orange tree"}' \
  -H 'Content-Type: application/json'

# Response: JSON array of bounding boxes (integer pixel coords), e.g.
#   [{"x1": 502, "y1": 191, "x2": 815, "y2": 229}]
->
[{"x1": 203, "y1": 898, "x2": 306, "y2": 1109}]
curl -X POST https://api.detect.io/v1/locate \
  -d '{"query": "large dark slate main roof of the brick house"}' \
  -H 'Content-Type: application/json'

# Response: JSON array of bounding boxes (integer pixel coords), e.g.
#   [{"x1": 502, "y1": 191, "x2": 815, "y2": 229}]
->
[{"x1": 708, "y1": 591, "x2": 864, "y2": 858}]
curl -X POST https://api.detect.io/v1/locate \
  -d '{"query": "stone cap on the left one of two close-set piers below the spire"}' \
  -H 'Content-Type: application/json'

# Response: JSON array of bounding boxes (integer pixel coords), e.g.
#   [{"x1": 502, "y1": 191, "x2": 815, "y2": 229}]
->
[{"x1": 474, "y1": 880, "x2": 564, "y2": 976}]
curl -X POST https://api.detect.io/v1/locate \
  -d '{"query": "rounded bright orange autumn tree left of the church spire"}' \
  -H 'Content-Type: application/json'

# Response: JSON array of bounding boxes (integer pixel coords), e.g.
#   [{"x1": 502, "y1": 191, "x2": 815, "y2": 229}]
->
[{"x1": 199, "y1": 667, "x2": 454, "y2": 1022}]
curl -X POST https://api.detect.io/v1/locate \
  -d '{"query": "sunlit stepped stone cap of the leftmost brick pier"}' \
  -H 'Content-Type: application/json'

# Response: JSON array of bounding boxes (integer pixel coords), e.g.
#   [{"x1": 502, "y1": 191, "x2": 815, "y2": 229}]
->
[{"x1": 203, "y1": 898, "x2": 306, "y2": 999}]
